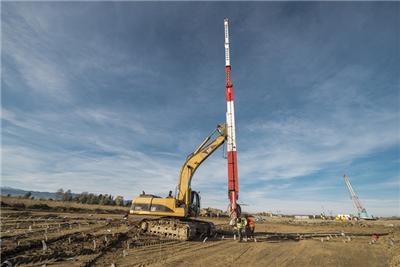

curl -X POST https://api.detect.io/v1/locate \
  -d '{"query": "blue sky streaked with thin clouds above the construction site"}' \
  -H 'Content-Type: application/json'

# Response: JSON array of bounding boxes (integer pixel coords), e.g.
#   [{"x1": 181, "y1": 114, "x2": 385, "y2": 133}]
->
[{"x1": 1, "y1": 2, "x2": 400, "y2": 218}]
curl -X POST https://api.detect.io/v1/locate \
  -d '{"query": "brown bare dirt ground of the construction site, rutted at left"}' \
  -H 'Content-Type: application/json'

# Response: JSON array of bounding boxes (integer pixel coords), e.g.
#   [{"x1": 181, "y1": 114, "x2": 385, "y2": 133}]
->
[{"x1": 1, "y1": 209, "x2": 400, "y2": 266}]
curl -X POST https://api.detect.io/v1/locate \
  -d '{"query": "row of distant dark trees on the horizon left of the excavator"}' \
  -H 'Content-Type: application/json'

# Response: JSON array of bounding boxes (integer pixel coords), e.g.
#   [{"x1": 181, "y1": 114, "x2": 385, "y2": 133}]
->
[{"x1": 56, "y1": 188, "x2": 131, "y2": 206}]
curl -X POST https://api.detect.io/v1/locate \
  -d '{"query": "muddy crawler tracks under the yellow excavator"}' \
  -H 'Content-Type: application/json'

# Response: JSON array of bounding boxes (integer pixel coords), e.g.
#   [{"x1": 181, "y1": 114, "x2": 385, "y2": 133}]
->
[{"x1": 140, "y1": 217, "x2": 216, "y2": 241}]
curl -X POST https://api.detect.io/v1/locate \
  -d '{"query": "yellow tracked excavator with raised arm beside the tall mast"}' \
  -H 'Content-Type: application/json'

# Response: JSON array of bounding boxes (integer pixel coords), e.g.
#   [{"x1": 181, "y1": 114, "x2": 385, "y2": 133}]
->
[{"x1": 130, "y1": 123, "x2": 226, "y2": 240}]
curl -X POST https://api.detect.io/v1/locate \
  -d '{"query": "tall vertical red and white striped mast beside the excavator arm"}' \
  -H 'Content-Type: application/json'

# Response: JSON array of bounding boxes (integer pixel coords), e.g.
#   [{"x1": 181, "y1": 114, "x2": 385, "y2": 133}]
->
[{"x1": 224, "y1": 18, "x2": 240, "y2": 222}]
